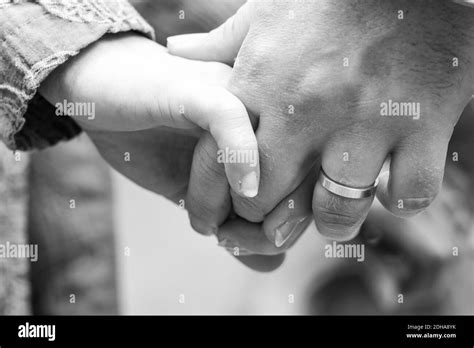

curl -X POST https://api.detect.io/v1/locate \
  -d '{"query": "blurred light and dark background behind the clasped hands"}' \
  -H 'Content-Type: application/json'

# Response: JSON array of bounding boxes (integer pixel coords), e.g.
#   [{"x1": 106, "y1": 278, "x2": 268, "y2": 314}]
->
[{"x1": 0, "y1": 0, "x2": 474, "y2": 314}]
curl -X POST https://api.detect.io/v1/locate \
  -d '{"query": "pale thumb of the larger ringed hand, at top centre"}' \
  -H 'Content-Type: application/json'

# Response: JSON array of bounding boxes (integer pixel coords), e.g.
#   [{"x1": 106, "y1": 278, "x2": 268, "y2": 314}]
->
[{"x1": 167, "y1": 3, "x2": 251, "y2": 65}]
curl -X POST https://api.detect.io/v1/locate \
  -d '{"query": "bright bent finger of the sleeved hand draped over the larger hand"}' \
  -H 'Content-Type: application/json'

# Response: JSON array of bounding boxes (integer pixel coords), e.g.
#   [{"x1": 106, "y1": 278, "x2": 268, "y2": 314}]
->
[{"x1": 170, "y1": 86, "x2": 260, "y2": 197}]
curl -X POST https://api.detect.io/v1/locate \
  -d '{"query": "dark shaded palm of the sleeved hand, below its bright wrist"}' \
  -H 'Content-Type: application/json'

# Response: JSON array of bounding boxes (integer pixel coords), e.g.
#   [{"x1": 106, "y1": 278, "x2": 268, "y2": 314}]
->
[{"x1": 89, "y1": 127, "x2": 199, "y2": 204}]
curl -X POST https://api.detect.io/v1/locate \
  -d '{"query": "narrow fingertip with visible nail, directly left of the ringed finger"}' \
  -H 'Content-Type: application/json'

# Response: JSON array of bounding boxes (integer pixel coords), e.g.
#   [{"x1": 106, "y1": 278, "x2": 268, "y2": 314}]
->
[{"x1": 263, "y1": 166, "x2": 319, "y2": 247}]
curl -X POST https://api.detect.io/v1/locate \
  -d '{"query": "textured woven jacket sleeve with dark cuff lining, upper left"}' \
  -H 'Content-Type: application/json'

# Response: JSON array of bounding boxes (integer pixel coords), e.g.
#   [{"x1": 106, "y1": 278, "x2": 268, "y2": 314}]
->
[{"x1": 0, "y1": 0, "x2": 154, "y2": 150}]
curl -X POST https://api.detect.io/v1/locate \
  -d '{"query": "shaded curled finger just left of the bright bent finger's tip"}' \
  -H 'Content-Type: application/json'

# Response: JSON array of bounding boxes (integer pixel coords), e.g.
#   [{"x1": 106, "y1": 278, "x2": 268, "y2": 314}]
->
[{"x1": 186, "y1": 134, "x2": 231, "y2": 235}]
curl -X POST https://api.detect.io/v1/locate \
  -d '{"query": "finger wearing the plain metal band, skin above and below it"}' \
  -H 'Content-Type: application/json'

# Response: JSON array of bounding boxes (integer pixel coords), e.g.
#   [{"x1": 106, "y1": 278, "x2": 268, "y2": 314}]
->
[{"x1": 313, "y1": 138, "x2": 387, "y2": 241}]
